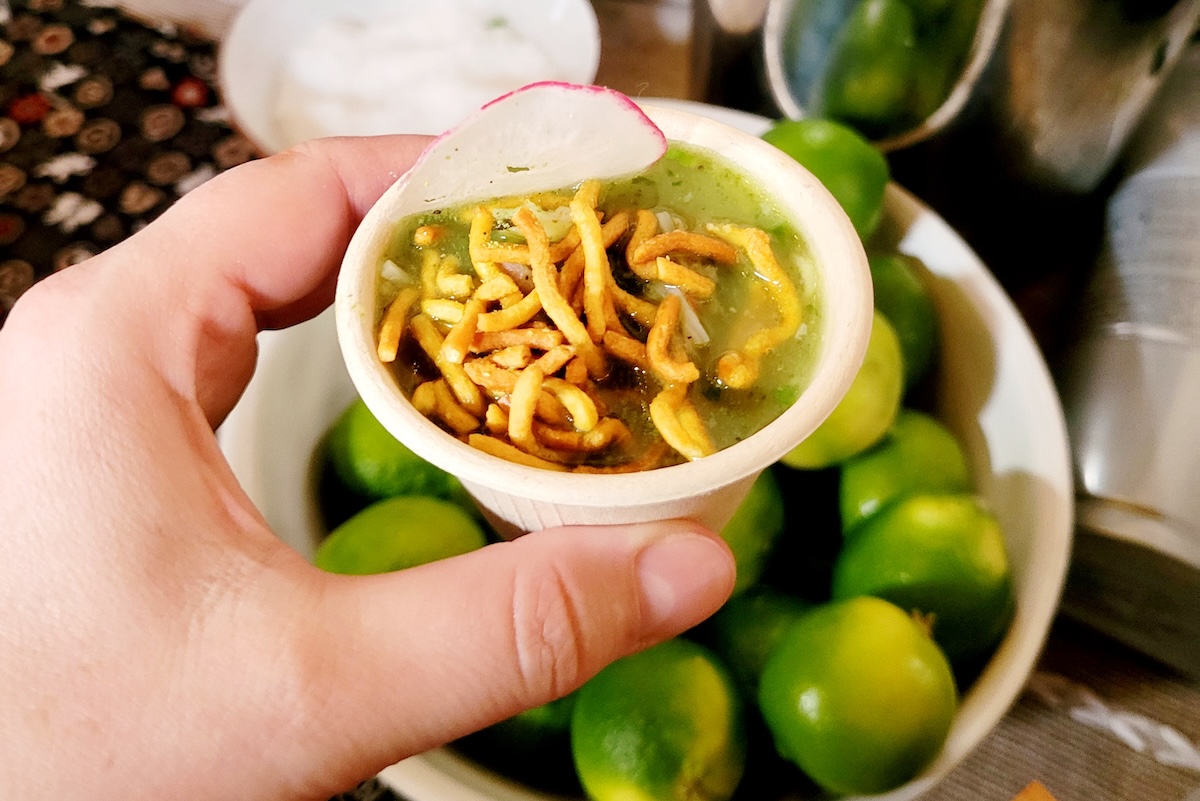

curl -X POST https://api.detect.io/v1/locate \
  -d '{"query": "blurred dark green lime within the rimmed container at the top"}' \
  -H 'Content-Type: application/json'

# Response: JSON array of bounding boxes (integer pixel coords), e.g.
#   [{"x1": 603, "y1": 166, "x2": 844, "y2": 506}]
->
[{"x1": 820, "y1": 0, "x2": 917, "y2": 137}]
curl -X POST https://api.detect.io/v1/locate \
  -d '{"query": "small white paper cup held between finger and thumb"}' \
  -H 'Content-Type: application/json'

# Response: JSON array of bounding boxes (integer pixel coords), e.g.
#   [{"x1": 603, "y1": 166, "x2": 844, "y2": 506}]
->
[{"x1": 335, "y1": 107, "x2": 872, "y2": 536}]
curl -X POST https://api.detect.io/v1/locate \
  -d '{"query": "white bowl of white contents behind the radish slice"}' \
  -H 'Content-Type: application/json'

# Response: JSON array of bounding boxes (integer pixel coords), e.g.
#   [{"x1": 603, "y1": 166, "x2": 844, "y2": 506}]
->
[{"x1": 218, "y1": 0, "x2": 600, "y2": 152}]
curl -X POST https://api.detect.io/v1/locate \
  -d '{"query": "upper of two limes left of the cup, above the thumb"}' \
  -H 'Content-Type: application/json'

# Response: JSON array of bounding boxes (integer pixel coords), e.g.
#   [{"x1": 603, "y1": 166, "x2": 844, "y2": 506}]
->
[{"x1": 325, "y1": 398, "x2": 469, "y2": 502}]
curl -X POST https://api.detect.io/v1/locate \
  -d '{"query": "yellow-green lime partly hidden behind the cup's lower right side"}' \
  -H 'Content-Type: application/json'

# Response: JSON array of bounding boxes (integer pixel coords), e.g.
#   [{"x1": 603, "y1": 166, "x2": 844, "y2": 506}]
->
[{"x1": 781, "y1": 312, "x2": 904, "y2": 469}]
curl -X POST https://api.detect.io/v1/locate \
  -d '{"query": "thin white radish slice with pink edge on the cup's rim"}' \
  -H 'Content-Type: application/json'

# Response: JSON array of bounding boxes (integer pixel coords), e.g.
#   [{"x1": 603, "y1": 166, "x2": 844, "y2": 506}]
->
[{"x1": 391, "y1": 82, "x2": 667, "y2": 221}]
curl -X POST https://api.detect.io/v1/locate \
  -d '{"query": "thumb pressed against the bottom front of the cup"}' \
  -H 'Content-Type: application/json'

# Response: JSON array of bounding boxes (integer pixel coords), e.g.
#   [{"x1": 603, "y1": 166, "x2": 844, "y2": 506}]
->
[{"x1": 295, "y1": 520, "x2": 734, "y2": 789}]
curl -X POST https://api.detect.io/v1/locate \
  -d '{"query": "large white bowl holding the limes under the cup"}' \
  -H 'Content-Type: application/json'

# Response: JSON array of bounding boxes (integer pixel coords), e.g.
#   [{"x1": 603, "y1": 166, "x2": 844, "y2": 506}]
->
[{"x1": 220, "y1": 100, "x2": 1074, "y2": 801}]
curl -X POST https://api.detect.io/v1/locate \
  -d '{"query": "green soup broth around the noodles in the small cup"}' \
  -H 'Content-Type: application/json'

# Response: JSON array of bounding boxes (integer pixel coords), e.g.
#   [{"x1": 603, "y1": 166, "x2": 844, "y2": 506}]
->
[{"x1": 379, "y1": 144, "x2": 821, "y2": 466}]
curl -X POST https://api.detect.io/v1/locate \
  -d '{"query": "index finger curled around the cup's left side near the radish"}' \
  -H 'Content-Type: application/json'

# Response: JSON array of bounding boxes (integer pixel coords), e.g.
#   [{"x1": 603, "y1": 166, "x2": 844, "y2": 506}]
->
[{"x1": 126, "y1": 135, "x2": 430, "y2": 327}]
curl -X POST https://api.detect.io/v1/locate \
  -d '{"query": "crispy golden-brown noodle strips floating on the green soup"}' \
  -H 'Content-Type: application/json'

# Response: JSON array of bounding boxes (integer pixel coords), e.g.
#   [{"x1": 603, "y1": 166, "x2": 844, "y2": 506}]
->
[{"x1": 378, "y1": 181, "x2": 803, "y2": 472}]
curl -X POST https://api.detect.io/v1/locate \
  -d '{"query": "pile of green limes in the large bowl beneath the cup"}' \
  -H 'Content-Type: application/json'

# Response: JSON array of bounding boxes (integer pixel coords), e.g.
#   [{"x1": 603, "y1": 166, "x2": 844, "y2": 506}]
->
[{"x1": 316, "y1": 120, "x2": 1013, "y2": 801}]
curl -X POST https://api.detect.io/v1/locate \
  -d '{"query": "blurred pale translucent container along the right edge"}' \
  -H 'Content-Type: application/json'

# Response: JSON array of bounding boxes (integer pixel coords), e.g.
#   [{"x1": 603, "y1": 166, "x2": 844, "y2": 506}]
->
[{"x1": 1062, "y1": 42, "x2": 1200, "y2": 676}]
